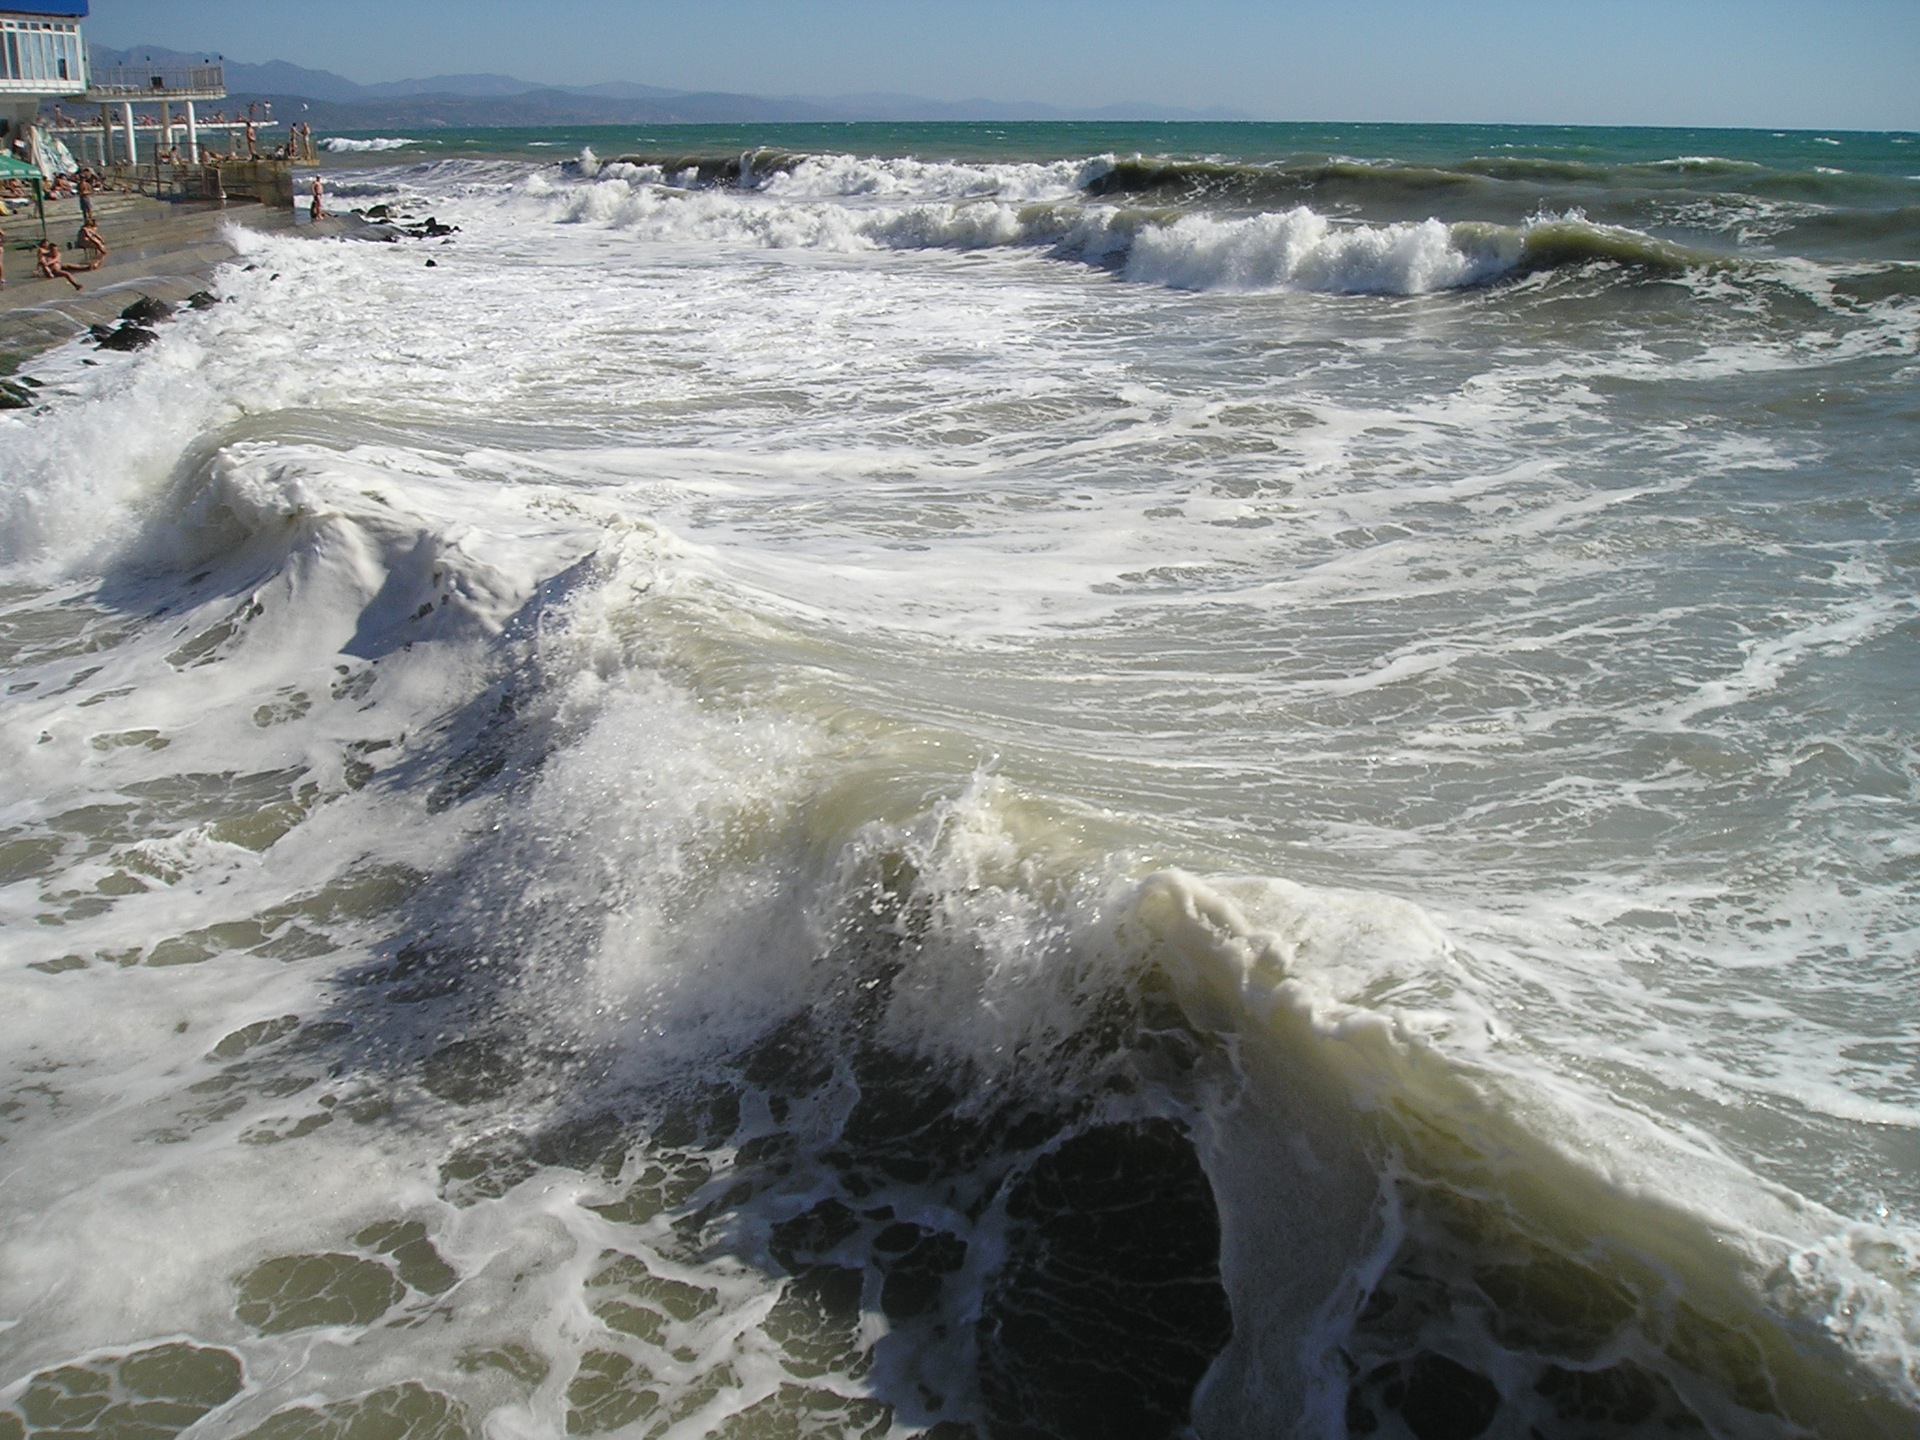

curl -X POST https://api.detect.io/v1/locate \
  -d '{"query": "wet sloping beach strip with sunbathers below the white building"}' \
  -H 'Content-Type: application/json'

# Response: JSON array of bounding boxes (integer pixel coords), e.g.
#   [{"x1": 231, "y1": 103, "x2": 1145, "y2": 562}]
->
[{"x1": 0, "y1": 194, "x2": 355, "y2": 378}]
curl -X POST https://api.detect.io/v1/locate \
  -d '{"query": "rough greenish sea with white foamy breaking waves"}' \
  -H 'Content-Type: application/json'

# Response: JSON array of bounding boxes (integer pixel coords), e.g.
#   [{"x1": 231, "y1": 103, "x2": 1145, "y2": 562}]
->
[{"x1": 0, "y1": 125, "x2": 1920, "y2": 1440}]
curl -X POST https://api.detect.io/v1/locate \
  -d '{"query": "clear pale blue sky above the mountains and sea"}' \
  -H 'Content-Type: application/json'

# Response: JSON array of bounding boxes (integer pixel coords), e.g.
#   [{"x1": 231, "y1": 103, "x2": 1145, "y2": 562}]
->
[{"x1": 86, "y1": 0, "x2": 1920, "y2": 131}]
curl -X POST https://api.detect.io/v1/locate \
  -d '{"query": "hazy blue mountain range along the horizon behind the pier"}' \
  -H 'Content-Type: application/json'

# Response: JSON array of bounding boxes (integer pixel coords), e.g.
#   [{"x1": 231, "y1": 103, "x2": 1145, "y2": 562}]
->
[{"x1": 92, "y1": 46, "x2": 1248, "y2": 131}]
